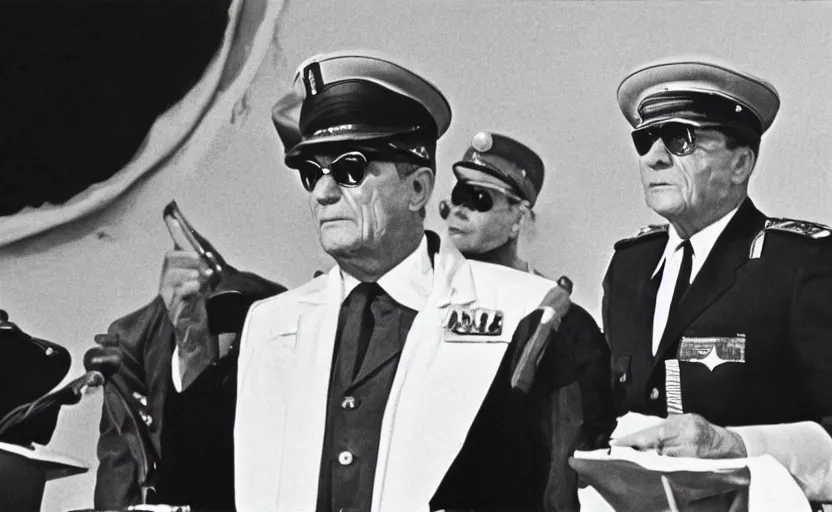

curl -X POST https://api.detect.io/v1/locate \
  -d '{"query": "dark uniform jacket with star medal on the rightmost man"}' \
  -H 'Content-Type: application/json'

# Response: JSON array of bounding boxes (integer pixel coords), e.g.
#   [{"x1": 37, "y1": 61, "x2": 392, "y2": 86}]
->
[{"x1": 604, "y1": 199, "x2": 832, "y2": 430}]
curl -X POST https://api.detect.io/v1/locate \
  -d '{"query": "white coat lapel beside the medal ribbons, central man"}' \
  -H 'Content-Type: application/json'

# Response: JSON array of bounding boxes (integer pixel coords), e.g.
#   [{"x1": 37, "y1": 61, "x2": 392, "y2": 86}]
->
[{"x1": 372, "y1": 241, "x2": 511, "y2": 512}]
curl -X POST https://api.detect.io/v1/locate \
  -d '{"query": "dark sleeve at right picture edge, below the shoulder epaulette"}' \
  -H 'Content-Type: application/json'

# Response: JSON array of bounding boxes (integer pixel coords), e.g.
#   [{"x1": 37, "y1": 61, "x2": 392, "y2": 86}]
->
[{"x1": 790, "y1": 240, "x2": 832, "y2": 434}]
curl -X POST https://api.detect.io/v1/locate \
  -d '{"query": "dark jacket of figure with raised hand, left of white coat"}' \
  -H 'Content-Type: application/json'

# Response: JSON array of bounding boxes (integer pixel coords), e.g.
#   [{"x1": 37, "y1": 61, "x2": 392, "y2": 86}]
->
[{"x1": 95, "y1": 271, "x2": 285, "y2": 510}]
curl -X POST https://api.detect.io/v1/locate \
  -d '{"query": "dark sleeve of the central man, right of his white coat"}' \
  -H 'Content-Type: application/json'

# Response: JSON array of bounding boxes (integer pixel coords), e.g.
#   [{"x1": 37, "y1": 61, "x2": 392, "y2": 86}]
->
[{"x1": 514, "y1": 311, "x2": 583, "y2": 512}]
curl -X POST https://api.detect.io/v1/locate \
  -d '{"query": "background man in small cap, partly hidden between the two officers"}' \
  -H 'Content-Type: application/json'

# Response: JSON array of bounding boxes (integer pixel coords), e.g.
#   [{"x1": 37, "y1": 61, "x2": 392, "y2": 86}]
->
[{"x1": 440, "y1": 132, "x2": 615, "y2": 456}]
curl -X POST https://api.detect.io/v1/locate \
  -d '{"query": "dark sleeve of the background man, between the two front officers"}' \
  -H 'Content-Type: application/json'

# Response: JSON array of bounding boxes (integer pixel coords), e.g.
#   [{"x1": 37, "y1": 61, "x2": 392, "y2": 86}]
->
[{"x1": 559, "y1": 304, "x2": 616, "y2": 450}]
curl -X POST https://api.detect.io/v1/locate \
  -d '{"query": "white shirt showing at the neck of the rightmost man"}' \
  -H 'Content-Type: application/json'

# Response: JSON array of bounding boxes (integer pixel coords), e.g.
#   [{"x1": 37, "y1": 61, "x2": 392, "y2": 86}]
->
[{"x1": 652, "y1": 207, "x2": 739, "y2": 356}]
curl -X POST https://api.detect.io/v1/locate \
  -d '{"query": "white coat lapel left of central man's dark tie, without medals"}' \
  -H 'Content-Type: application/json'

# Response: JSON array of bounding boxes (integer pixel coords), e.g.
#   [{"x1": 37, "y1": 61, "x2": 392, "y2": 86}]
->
[{"x1": 274, "y1": 266, "x2": 343, "y2": 510}]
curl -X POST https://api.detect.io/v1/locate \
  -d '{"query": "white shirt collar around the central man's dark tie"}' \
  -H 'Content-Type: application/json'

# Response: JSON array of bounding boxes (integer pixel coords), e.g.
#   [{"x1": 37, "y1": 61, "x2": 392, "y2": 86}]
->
[{"x1": 341, "y1": 235, "x2": 433, "y2": 311}]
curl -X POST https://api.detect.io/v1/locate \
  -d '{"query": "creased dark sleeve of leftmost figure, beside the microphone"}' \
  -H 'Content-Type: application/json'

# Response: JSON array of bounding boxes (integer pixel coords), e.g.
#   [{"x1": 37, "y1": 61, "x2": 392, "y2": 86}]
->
[{"x1": 94, "y1": 297, "x2": 170, "y2": 510}]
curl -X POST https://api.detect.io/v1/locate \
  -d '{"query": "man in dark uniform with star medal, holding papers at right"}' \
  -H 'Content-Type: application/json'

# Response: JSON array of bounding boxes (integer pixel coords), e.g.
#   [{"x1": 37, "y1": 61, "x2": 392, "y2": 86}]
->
[{"x1": 603, "y1": 61, "x2": 832, "y2": 501}]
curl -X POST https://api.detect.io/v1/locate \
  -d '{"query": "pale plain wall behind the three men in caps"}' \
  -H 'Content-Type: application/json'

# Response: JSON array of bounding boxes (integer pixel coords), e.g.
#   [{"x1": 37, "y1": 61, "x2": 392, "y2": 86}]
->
[{"x1": 0, "y1": 0, "x2": 832, "y2": 512}]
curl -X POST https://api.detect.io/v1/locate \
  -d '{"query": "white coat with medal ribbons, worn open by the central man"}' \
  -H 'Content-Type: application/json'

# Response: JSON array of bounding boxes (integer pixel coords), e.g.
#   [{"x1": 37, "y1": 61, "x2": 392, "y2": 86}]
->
[{"x1": 234, "y1": 241, "x2": 554, "y2": 512}]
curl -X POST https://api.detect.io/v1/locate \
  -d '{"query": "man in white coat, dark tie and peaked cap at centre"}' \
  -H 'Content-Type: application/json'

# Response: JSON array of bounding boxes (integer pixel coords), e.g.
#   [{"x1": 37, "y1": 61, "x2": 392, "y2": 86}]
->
[{"x1": 235, "y1": 53, "x2": 592, "y2": 512}]
